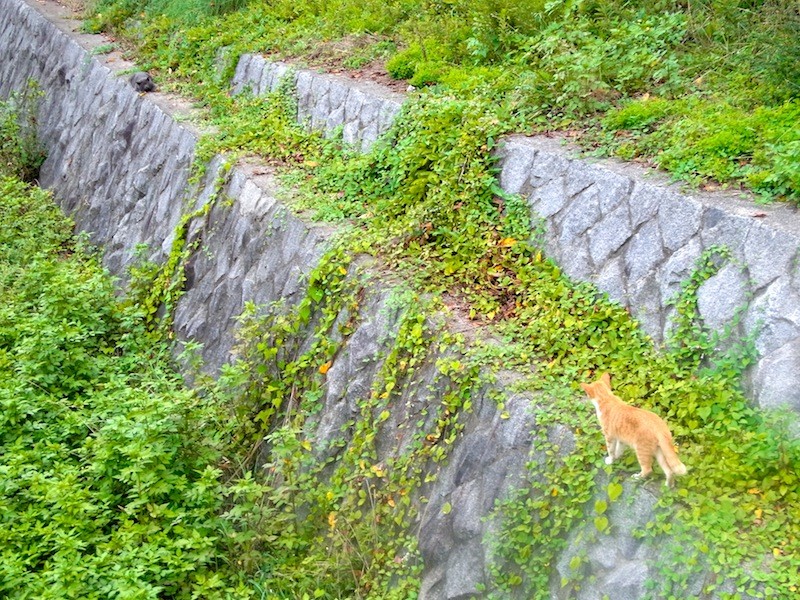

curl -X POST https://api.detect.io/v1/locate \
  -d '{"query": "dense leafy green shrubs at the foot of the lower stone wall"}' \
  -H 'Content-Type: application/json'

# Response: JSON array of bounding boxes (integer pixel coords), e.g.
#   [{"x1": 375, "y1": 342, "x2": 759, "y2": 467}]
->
[{"x1": 0, "y1": 178, "x2": 256, "y2": 598}]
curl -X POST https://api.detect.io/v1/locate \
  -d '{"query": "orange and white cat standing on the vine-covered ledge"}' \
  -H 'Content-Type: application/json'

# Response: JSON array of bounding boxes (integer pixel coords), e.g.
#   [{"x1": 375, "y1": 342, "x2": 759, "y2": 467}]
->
[{"x1": 581, "y1": 373, "x2": 686, "y2": 487}]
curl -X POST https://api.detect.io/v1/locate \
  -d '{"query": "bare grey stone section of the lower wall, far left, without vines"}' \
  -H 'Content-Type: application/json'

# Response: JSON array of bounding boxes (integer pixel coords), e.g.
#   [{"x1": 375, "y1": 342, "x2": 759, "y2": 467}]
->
[{"x1": 0, "y1": 0, "x2": 196, "y2": 275}]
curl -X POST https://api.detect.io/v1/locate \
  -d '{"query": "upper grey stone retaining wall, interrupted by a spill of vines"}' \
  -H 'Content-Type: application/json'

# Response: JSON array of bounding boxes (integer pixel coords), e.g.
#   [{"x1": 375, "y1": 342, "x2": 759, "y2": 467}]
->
[{"x1": 234, "y1": 55, "x2": 800, "y2": 412}]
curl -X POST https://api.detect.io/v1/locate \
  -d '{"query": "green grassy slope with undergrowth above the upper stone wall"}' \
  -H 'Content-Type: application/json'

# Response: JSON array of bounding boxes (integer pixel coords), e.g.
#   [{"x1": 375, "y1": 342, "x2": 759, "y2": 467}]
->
[{"x1": 84, "y1": 0, "x2": 800, "y2": 202}]
